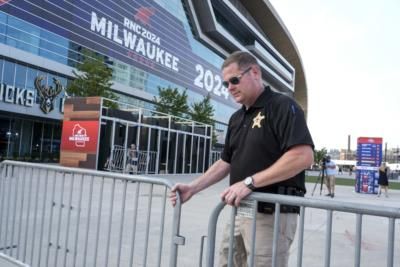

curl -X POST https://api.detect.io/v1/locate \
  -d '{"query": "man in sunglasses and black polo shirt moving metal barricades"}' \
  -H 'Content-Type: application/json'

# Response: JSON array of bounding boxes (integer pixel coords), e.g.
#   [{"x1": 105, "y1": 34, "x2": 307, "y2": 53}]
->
[{"x1": 170, "y1": 51, "x2": 314, "y2": 266}]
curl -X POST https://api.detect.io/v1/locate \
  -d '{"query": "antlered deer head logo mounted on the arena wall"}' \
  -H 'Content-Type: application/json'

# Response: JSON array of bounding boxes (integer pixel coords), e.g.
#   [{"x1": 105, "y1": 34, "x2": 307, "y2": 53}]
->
[{"x1": 35, "y1": 76, "x2": 63, "y2": 114}]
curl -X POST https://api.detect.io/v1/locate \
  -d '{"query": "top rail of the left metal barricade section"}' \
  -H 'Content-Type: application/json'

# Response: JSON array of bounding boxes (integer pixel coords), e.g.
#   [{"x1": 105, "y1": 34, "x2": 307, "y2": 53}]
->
[{"x1": 0, "y1": 160, "x2": 173, "y2": 189}]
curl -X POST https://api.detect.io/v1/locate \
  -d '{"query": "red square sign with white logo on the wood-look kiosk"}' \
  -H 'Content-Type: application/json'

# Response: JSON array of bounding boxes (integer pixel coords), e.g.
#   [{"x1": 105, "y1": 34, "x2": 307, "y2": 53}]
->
[{"x1": 61, "y1": 121, "x2": 99, "y2": 153}]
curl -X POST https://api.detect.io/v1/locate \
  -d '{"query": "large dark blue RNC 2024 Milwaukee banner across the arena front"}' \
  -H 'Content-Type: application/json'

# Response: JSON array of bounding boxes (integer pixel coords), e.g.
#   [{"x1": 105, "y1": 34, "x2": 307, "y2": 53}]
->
[{"x1": 0, "y1": 0, "x2": 237, "y2": 107}]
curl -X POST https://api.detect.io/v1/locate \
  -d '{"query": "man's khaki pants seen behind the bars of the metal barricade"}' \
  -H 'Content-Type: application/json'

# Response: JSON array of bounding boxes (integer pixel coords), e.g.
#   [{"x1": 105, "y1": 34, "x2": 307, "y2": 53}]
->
[{"x1": 219, "y1": 212, "x2": 298, "y2": 267}]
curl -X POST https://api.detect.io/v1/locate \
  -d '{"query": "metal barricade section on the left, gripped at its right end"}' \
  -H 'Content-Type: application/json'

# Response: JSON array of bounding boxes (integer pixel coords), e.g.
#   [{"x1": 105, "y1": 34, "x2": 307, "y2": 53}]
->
[{"x1": 0, "y1": 161, "x2": 185, "y2": 267}]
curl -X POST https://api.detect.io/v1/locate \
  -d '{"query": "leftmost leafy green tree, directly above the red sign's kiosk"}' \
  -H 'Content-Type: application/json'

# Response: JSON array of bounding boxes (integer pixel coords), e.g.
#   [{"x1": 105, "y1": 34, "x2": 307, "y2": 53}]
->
[{"x1": 67, "y1": 49, "x2": 118, "y2": 104}]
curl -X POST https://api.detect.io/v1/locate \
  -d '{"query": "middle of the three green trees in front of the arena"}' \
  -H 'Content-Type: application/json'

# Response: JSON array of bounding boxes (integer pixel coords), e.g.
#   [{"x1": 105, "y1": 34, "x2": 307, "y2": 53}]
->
[{"x1": 154, "y1": 86, "x2": 189, "y2": 118}]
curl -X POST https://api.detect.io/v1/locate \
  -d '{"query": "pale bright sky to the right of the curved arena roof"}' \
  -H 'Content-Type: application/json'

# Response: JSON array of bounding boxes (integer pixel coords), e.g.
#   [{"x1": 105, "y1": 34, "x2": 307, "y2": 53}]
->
[{"x1": 270, "y1": 0, "x2": 400, "y2": 150}]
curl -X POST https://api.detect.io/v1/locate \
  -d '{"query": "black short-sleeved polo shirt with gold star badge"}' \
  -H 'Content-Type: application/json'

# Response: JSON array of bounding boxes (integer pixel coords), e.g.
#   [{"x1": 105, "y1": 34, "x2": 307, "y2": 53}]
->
[{"x1": 221, "y1": 87, "x2": 314, "y2": 193}]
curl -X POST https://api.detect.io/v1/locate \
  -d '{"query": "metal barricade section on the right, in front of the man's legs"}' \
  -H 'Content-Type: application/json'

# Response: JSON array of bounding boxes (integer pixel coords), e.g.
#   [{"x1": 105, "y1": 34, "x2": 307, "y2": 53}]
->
[{"x1": 205, "y1": 193, "x2": 400, "y2": 267}]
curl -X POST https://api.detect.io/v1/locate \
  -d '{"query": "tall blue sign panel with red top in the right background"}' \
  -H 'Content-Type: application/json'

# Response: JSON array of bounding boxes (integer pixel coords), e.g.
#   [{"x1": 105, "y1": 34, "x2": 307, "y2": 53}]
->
[{"x1": 355, "y1": 137, "x2": 382, "y2": 194}]
